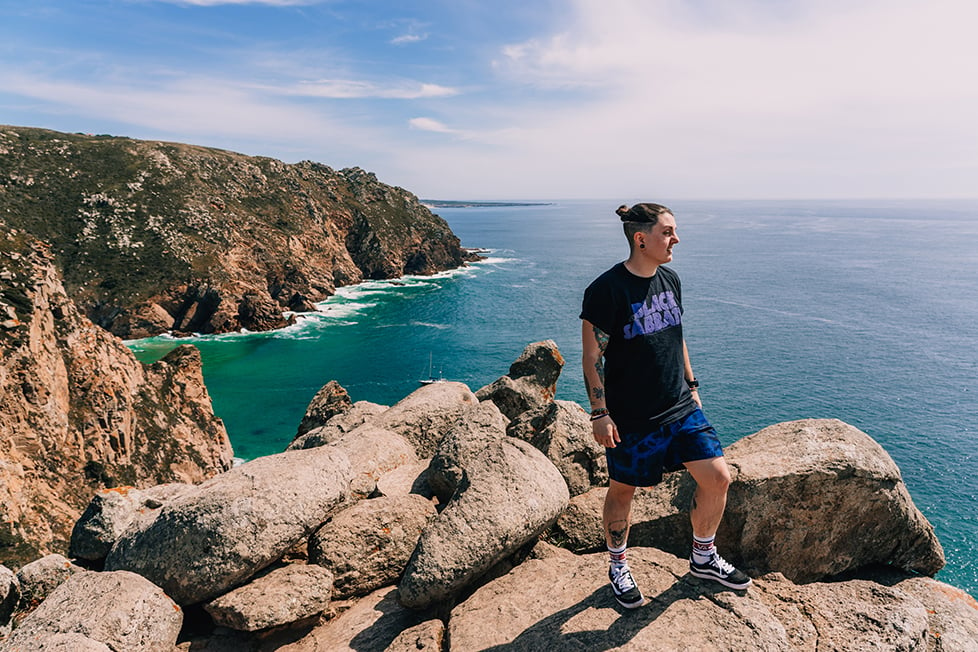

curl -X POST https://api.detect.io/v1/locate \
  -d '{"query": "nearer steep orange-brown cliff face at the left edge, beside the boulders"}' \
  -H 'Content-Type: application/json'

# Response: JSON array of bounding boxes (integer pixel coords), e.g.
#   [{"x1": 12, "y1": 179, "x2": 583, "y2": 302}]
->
[{"x1": 0, "y1": 223, "x2": 231, "y2": 566}]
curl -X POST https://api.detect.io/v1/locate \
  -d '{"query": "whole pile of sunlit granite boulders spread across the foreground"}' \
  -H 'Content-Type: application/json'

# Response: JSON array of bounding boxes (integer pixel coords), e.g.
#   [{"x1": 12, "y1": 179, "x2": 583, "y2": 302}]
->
[{"x1": 0, "y1": 344, "x2": 978, "y2": 652}]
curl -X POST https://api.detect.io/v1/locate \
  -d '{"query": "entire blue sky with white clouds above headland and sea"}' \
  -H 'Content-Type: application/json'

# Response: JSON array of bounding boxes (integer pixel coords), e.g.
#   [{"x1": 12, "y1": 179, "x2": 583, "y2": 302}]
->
[{"x1": 0, "y1": 0, "x2": 978, "y2": 201}]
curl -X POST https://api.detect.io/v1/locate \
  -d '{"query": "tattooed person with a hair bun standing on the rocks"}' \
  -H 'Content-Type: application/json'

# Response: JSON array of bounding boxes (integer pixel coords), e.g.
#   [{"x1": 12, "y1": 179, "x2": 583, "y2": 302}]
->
[{"x1": 581, "y1": 203, "x2": 751, "y2": 608}]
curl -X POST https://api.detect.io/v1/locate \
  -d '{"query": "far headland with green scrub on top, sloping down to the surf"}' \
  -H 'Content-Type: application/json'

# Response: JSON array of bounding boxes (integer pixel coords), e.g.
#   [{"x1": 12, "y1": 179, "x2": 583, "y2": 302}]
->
[{"x1": 0, "y1": 126, "x2": 471, "y2": 338}]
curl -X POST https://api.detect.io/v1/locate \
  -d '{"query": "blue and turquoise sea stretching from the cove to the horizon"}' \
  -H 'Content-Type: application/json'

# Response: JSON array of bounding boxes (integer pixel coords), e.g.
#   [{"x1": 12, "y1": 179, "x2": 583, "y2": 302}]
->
[{"x1": 131, "y1": 201, "x2": 978, "y2": 595}]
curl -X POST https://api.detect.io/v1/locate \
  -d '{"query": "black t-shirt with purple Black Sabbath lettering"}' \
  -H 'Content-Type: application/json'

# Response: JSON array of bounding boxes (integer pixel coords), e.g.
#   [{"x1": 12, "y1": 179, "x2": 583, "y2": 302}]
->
[{"x1": 581, "y1": 263, "x2": 696, "y2": 432}]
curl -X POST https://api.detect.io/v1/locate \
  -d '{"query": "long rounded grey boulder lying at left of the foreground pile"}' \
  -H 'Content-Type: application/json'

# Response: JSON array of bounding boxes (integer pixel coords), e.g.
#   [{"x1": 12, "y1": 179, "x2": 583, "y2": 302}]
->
[{"x1": 105, "y1": 446, "x2": 352, "y2": 604}]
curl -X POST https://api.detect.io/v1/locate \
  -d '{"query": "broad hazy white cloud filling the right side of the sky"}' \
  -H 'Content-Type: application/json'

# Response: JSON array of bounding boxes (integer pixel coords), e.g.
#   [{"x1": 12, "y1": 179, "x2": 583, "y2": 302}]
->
[{"x1": 454, "y1": 0, "x2": 978, "y2": 196}]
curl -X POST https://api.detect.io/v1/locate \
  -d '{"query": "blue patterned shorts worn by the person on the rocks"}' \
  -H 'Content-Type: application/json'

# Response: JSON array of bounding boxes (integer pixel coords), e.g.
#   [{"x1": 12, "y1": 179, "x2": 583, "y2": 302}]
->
[{"x1": 605, "y1": 408, "x2": 723, "y2": 487}]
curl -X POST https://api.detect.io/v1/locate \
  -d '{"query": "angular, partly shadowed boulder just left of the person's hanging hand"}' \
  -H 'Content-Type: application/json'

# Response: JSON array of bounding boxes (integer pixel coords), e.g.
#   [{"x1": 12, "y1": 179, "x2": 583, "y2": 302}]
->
[{"x1": 506, "y1": 401, "x2": 608, "y2": 496}]
